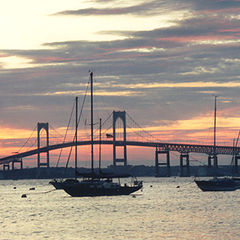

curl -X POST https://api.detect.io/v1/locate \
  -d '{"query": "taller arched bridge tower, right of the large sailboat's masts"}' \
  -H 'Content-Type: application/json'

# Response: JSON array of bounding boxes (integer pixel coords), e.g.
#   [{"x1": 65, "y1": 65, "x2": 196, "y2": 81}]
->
[{"x1": 113, "y1": 111, "x2": 127, "y2": 166}]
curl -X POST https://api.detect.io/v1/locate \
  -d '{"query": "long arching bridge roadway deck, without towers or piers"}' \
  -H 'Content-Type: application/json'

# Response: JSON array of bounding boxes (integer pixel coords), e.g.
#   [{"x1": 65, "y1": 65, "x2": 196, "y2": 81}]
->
[{"x1": 0, "y1": 140, "x2": 240, "y2": 165}]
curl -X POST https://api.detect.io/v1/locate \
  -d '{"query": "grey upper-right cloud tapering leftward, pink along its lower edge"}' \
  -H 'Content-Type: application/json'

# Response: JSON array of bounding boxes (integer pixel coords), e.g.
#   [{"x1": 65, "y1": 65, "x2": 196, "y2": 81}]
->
[{"x1": 111, "y1": 16, "x2": 240, "y2": 42}]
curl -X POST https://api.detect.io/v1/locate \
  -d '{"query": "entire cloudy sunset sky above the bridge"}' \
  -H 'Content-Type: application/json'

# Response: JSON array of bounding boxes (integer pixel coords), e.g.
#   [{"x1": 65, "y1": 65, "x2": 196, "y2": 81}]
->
[{"x1": 0, "y1": 0, "x2": 240, "y2": 167}]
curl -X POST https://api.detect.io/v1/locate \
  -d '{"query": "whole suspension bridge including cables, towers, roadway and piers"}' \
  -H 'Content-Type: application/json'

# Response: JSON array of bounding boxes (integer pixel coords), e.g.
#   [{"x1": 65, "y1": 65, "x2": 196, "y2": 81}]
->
[{"x1": 0, "y1": 111, "x2": 240, "y2": 176}]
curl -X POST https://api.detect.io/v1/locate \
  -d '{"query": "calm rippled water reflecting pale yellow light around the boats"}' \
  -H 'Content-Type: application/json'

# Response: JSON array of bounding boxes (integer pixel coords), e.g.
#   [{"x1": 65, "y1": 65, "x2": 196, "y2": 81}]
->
[{"x1": 0, "y1": 178, "x2": 240, "y2": 240}]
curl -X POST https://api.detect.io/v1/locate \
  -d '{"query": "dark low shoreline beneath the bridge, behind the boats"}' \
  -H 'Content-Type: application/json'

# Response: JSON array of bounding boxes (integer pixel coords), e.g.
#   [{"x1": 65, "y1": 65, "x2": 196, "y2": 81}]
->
[{"x1": 0, "y1": 165, "x2": 236, "y2": 180}]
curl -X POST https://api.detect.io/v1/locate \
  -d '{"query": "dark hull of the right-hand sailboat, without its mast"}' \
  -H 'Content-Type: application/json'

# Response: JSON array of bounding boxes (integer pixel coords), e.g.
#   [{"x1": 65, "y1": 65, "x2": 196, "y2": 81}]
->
[{"x1": 195, "y1": 179, "x2": 240, "y2": 192}]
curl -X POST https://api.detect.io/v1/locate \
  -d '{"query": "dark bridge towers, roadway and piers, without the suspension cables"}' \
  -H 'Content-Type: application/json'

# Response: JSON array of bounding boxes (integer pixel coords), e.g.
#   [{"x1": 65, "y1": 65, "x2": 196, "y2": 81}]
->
[{"x1": 0, "y1": 111, "x2": 240, "y2": 176}]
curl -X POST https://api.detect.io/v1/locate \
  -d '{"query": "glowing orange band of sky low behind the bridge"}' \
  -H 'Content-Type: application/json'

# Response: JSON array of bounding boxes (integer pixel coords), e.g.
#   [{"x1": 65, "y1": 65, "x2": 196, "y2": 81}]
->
[{"x1": 0, "y1": 110, "x2": 240, "y2": 166}]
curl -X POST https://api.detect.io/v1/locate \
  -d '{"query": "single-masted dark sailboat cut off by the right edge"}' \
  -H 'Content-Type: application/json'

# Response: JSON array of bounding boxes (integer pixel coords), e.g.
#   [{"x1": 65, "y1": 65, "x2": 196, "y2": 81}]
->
[{"x1": 194, "y1": 96, "x2": 240, "y2": 192}]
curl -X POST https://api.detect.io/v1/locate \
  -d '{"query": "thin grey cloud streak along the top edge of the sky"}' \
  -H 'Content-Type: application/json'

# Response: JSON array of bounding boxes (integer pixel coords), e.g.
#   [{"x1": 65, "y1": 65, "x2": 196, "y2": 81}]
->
[{"x1": 54, "y1": 0, "x2": 240, "y2": 16}]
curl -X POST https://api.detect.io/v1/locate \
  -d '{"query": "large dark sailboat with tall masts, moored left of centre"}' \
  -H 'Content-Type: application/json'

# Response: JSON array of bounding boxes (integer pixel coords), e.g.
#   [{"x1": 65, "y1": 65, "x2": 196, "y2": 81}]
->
[{"x1": 50, "y1": 72, "x2": 143, "y2": 197}]
